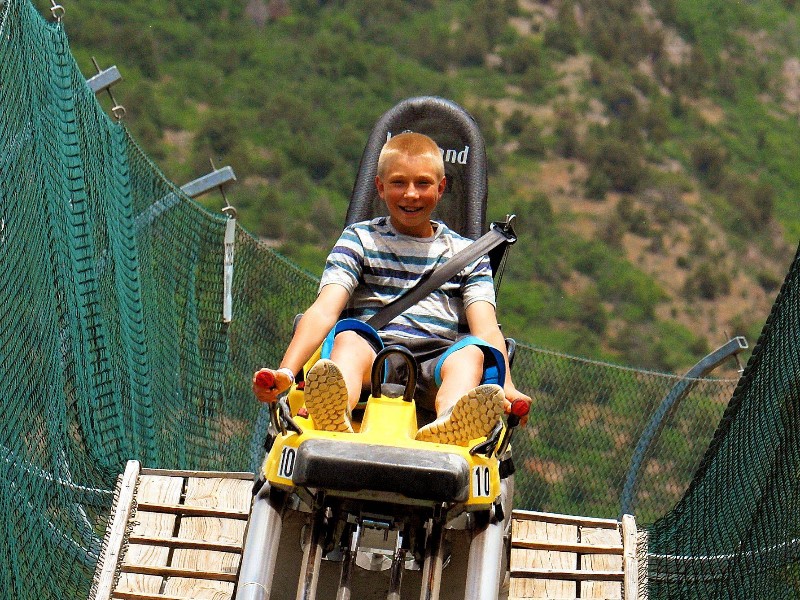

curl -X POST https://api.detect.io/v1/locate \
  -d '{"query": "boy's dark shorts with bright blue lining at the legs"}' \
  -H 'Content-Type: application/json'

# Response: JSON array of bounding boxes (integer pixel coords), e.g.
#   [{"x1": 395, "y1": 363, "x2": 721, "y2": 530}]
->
[{"x1": 322, "y1": 319, "x2": 506, "y2": 411}]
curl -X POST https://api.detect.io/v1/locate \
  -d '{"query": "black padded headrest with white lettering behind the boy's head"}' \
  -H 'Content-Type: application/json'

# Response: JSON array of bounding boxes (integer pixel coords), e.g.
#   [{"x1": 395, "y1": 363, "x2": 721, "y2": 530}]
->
[{"x1": 346, "y1": 96, "x2": 488, "y2": 239}]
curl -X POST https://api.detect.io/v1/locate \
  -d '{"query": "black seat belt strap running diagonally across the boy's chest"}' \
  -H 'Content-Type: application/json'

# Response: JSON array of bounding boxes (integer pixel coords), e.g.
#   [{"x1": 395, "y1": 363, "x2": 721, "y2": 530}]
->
[{"x1": 367, "y1": 215, "x2": 517, "y2": 330}]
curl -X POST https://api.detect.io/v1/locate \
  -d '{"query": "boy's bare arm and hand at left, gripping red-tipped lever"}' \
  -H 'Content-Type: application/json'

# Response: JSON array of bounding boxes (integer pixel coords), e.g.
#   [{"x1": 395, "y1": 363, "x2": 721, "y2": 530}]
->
[{"x1": 253, "y1": 283, "x2": 350, "y2": 402}]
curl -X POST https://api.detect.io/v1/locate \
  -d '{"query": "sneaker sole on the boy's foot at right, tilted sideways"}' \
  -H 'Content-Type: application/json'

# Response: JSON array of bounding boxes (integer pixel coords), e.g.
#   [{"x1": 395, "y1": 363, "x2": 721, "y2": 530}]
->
[{"x1": 416, "y1": 384, "x2": 505, "y2": 446}]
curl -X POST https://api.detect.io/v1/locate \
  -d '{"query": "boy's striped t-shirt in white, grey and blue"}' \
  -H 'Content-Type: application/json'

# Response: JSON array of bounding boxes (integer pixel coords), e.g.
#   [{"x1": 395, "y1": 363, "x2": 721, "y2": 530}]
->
[{"x1": 320, "y1": 217, "x2": 495, "y2": 340}]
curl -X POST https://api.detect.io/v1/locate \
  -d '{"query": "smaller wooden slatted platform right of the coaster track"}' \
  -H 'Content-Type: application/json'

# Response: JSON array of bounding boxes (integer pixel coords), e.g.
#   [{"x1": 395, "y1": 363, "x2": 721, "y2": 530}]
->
[{"x1": 508, "y1": 510, "x2": 638, "y2": 600}]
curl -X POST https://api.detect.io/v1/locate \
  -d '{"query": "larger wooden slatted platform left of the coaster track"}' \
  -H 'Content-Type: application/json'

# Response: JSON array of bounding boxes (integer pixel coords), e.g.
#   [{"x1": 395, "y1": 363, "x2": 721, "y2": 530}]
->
[{"x1": 90, "y1": 461, "x2": 253, "y2": 600}]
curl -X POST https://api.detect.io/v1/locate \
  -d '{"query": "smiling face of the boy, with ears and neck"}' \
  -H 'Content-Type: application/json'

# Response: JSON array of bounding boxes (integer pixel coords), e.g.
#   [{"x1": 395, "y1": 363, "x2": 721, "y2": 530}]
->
[{"x1": 375, "y1": 154, "x2": 446, "y2": 237}]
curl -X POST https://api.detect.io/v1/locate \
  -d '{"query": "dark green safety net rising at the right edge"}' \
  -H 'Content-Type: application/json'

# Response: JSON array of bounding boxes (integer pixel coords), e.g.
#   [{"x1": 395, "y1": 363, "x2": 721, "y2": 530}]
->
[{"x1": 644, "y1": 240, "x2": 800, "y2": 600}]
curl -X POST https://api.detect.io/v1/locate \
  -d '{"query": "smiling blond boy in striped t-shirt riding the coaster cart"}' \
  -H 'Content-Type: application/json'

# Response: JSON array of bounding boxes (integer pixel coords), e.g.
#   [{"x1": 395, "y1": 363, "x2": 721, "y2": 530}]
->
[{"x1": 253, "y1": 132, "x2": 530, "y2": 445}]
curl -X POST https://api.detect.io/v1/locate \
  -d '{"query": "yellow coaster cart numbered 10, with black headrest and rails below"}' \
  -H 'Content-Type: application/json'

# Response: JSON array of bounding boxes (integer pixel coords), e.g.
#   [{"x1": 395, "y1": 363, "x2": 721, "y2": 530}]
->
[{"x1": 236, "y1": 97, "x2": 528, "y2": 600}]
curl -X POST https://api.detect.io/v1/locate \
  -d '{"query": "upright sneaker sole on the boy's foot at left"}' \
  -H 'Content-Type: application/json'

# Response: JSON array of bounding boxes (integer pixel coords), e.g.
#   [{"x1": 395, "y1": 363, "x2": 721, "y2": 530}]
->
[{"x1": 303, "y1": 358, "x2": 353, "y2": 433}]
